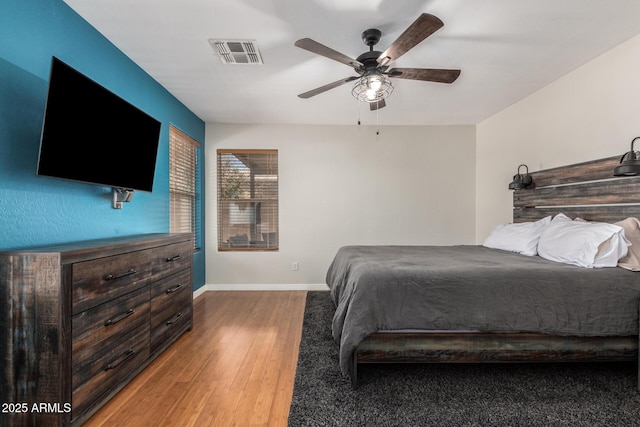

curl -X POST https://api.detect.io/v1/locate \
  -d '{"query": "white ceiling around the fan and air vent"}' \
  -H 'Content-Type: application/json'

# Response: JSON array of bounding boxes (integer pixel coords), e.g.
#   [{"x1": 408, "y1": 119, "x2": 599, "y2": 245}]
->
[{"x1": 65, "y1": 0, "x2": 640, "y2": 125}]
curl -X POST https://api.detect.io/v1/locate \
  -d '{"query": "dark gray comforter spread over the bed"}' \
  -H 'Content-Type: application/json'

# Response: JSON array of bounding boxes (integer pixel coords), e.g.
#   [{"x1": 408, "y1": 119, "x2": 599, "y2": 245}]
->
[{"x1": 327, "y1": 246, "x2": 640, "y2": 374}]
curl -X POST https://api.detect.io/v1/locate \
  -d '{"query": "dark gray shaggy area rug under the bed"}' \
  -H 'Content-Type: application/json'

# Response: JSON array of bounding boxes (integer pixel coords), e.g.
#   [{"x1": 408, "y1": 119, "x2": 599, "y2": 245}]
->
[{"x1": 289, "y1": 292, "x2": 640, "y2": 427}]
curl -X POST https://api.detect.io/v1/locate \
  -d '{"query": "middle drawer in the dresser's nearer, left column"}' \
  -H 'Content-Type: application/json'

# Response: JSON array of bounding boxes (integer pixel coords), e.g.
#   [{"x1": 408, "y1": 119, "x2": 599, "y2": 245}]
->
[{"x1": 71, "y1": 286, "x2": 150, "y2": 366}]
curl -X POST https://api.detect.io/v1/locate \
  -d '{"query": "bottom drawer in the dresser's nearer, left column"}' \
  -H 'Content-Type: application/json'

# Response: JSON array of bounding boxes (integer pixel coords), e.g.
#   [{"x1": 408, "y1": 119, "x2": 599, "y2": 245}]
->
[{"x1": 72, "y1": 322, "x2": 149, "y2": 418}]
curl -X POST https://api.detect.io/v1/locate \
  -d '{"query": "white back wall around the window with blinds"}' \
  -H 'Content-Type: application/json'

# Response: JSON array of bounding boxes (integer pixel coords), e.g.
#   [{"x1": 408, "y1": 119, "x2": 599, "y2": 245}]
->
[{"x1": 204, "y1": 124, "x2": 476, "y2": 288}]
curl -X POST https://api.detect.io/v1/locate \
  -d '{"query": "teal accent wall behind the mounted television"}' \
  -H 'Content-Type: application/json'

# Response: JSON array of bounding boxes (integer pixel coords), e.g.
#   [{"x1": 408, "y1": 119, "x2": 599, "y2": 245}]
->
[{"x1": 0, "y1": 0, "x2": 205, "y2": 289}]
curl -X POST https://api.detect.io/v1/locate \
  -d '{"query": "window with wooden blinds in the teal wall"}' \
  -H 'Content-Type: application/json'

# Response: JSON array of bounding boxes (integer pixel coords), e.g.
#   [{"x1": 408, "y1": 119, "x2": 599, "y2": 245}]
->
[{"x1": 169, "y1": 126, "x2": 200, "y2": 250}]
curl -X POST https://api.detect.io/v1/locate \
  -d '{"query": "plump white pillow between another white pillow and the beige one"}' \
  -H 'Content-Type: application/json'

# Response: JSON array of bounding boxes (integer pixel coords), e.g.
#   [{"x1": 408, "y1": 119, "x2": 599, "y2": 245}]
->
[{"x1": 538, "y1": 214, "x2": 630, "y2": 268}]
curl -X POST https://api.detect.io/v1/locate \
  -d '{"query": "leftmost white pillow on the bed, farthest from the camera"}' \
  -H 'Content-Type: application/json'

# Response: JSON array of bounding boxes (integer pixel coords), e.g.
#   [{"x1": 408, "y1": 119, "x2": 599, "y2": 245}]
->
[{"x1": 482, "y1": 216, "x2": 551, "y2": 256}]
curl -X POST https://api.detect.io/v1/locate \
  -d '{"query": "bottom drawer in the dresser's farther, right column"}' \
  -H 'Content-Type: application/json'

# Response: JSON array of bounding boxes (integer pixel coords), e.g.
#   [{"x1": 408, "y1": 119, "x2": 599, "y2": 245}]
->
[{"x1": 150, "y1": 301, "x2": 193, "y2": 353}]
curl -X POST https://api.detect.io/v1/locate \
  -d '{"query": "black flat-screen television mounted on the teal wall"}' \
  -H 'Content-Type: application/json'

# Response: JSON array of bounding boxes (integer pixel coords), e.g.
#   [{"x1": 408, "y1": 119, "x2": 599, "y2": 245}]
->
[{"x1": 37, "y1": 57, "x2": 161, "y2": 192}]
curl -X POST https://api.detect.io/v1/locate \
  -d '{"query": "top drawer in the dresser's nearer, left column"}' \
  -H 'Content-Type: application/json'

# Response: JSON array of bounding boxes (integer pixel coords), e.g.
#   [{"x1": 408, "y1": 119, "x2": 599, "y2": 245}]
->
[{"x1": 72, "y1": 250, "x2": 156, "y2": 314}]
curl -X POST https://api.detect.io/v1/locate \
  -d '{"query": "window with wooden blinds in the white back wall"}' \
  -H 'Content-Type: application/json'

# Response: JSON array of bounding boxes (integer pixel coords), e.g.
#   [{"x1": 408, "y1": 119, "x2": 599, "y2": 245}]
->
[{"x1": 217, "y1": 150, "x2": 278, "y2": 251}]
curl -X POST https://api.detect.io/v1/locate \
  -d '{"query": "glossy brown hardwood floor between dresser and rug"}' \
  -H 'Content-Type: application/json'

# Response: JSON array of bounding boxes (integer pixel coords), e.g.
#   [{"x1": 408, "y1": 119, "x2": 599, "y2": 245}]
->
[{"x1": 84, "y1": 291, "x2": 307, "y2": 427}]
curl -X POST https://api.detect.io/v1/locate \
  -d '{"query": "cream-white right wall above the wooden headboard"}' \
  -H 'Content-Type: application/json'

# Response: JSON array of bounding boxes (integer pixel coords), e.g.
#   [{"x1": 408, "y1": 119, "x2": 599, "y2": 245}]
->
[{"x1": 476, "y1": 32, "x2": 640, "y2": 243}]
